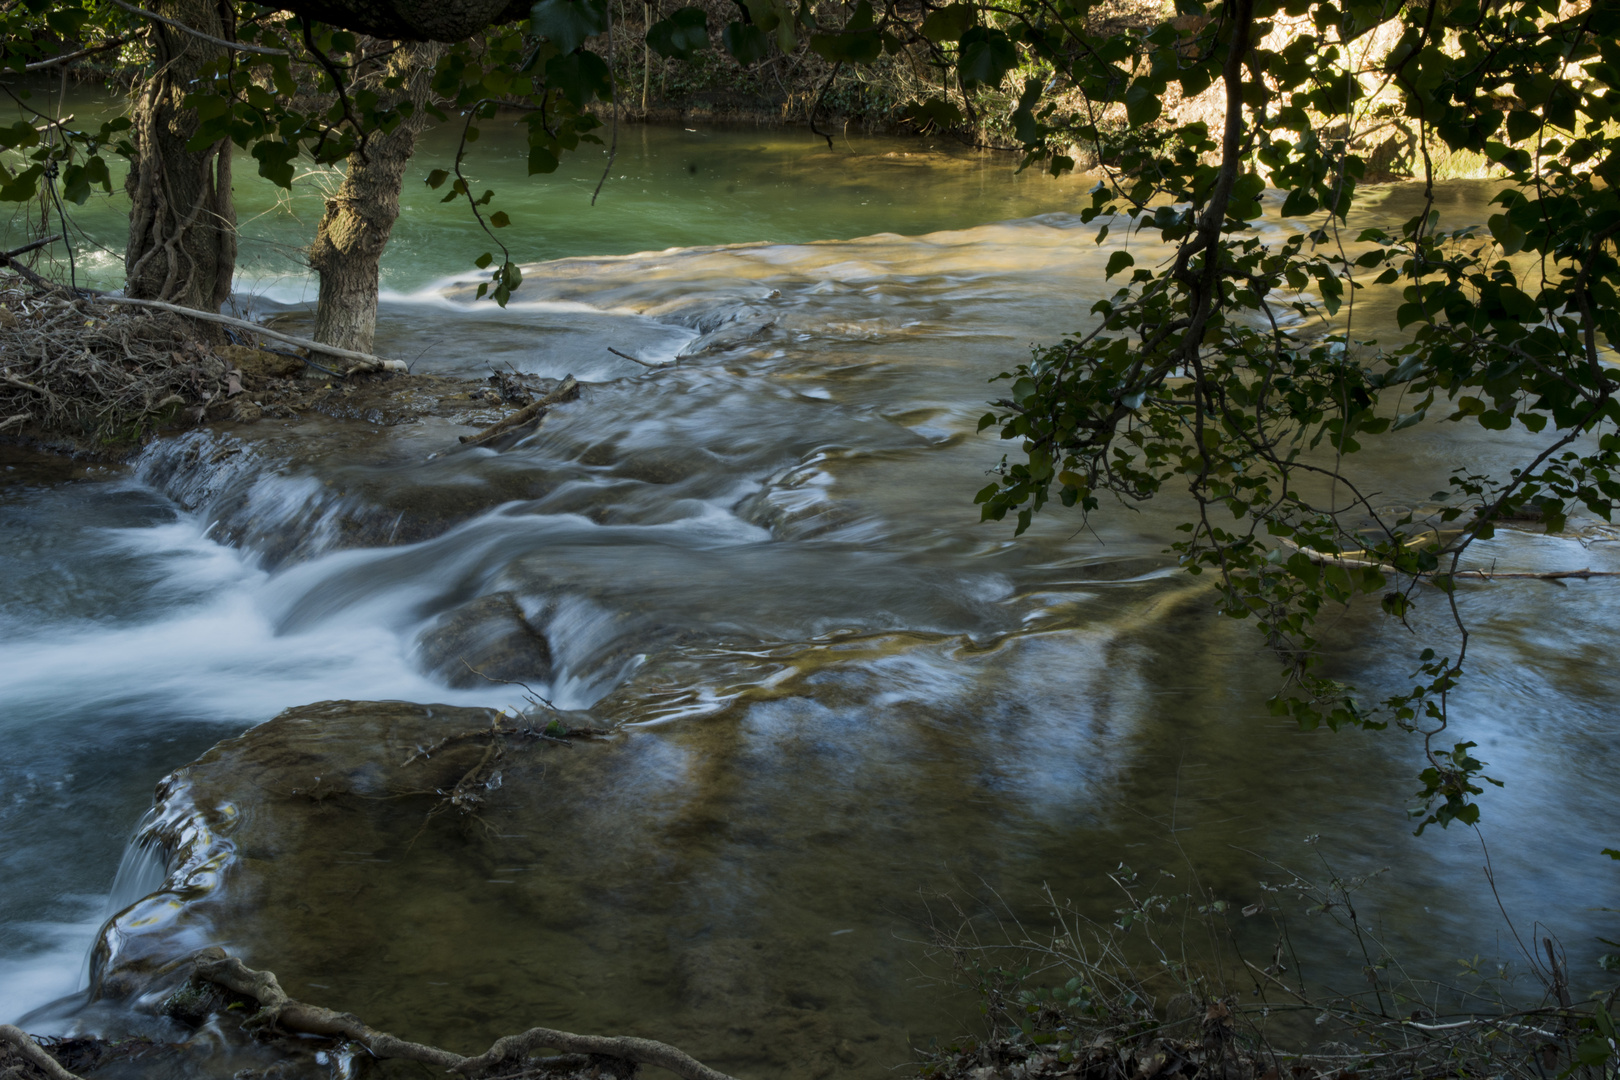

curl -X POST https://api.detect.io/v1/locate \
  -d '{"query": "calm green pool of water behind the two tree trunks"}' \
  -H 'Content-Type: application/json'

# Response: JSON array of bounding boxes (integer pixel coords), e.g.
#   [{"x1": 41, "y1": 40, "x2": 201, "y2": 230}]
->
[{"x1": 0, "y1": 89, "x2": 1089, "y2": 303}]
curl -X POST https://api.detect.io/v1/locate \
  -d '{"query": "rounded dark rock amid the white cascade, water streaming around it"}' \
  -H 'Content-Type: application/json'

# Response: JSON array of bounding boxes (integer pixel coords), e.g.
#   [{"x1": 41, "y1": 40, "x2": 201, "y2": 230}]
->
[{"x1": 416, "y1": 593, "x2": 551, "y2": 688}]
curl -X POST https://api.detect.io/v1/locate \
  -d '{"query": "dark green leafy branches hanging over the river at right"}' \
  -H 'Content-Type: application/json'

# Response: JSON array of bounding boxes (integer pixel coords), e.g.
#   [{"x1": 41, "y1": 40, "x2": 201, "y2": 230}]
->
[{"x1": 964, "y1": 0, "x2": 1620, "y2": 831}]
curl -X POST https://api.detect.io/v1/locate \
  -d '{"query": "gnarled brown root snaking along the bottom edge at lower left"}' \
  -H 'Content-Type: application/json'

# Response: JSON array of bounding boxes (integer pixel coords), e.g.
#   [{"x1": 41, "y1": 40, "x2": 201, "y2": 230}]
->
[{"x1": 187, "y1": 949, "x2": 732, "y2": 1080}]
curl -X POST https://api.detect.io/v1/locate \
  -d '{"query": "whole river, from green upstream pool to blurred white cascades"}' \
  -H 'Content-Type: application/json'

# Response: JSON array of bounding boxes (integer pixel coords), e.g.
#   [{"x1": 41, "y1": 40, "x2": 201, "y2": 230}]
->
[{"x1": 0, "y1": 90, "x2": 1620, "y2": 1075}]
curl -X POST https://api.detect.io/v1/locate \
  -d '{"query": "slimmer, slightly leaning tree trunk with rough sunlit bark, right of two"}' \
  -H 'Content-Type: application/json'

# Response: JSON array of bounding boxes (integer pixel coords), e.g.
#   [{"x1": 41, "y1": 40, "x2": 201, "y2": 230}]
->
[{"x1": 309, "y1": 42, "x2": 442, "y2": 353}]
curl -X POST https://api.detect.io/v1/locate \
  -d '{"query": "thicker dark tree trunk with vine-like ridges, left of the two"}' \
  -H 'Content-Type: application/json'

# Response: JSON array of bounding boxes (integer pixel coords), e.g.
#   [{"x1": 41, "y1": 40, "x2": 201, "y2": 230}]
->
[{"x1": 125, "y1": 0, "x2": 237, "y2": 311}]
